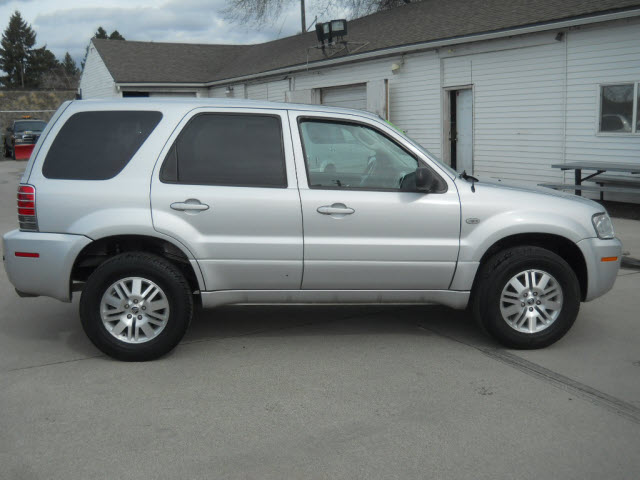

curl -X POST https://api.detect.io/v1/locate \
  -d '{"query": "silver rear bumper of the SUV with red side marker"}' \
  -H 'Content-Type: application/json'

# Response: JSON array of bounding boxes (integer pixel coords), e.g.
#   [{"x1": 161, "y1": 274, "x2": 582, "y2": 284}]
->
[{"x1": 2, "y1": 230, "x2": 91, "y2": 302}]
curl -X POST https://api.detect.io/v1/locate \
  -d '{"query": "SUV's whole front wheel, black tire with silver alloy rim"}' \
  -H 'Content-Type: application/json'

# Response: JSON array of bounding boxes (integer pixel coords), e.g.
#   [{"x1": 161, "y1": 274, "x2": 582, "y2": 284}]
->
[{"x1": 473, "y1": 246, "x2": 581, "y2": 349}]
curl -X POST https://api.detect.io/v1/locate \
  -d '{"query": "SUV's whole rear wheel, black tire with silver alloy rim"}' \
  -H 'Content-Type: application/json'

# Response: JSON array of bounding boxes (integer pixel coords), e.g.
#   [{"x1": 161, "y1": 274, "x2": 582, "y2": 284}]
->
[{"x1": 80, "y1": 252, "x2": 193, "y2": 361}]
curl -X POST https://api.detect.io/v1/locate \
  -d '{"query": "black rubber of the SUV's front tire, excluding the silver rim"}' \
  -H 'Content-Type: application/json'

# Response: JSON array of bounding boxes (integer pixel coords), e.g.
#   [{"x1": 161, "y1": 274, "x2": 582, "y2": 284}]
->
[{"x1": 479, "y1": 247, "x2": 580, "y2": 349}]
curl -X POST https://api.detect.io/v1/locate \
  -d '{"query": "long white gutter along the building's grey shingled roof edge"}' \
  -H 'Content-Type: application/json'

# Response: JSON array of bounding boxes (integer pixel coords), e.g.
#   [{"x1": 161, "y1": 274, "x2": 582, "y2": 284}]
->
[{"x1": 117, "y1": 8, "x2": 640, "y2": 88}]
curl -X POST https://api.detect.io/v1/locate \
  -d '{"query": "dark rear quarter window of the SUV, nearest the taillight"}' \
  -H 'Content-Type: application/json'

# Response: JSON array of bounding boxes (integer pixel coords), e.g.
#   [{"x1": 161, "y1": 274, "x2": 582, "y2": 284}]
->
[{"x1": 42, "y1": 111, "x2": 162, "y2": 180}]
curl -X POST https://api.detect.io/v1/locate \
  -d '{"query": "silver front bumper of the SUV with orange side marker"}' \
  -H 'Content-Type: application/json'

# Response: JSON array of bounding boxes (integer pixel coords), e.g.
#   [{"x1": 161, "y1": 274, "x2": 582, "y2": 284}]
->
[{"x1": 578, "y1": 238, "x2": 622, "y2": 302}]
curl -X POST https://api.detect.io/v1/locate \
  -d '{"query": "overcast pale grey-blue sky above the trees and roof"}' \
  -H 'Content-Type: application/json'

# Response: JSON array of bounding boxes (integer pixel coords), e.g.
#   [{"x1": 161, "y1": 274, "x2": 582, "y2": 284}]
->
[{"x1": 0, "y1": 0, "x2": 320, "y2": 63}]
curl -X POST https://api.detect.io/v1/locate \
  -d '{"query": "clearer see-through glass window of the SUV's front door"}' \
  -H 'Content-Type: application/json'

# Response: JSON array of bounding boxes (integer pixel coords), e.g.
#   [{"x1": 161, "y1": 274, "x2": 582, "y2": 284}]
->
[{"x1": 300, "y1": 120, "x2": 418, "y2": 190}]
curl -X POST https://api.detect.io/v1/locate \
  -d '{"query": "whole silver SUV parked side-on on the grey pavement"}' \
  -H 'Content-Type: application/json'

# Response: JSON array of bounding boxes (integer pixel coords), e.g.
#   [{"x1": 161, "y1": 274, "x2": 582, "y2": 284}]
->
[{"x1": 3, "y1": 99, "x2": 621, "y2": 360}]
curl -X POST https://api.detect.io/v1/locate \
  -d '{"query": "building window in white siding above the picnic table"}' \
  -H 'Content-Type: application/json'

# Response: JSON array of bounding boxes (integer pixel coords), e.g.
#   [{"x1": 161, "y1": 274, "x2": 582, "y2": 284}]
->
[{"x1": 599, "y1": 83, "x2": 640, "y2": 133}]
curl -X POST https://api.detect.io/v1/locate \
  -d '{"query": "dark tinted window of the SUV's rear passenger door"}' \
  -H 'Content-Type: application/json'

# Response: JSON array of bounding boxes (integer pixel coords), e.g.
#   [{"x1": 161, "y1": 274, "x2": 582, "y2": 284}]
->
[{"x1": 160, "y1": 114, "x2": 287, "y2": 187}]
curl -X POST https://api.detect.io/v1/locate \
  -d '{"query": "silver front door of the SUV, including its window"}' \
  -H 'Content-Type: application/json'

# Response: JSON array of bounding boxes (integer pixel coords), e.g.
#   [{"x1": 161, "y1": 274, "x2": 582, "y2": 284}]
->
[{"x1": 290, "y1": 112, "x2": 460, "y2": 290}]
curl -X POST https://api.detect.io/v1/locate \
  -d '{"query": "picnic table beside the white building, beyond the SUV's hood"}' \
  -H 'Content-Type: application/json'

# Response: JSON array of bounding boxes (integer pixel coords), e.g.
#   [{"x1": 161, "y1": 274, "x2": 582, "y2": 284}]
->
[{"x1": 540, "y1": 161, "x2": 640, "y2": 200}]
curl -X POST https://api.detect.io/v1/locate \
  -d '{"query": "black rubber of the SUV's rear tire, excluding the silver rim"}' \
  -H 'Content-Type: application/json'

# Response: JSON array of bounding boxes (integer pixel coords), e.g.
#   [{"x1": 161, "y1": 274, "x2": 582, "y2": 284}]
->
[{"x1": 80, "y1": 253, "x2": 193, "y2": 361}]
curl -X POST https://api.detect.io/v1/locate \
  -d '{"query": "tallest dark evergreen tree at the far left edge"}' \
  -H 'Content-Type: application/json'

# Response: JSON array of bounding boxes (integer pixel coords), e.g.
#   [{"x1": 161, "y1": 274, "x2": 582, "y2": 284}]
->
[{"x1": 0, "y1": 10, "x2": 36, "y2": 87}]
